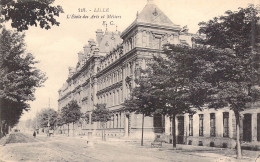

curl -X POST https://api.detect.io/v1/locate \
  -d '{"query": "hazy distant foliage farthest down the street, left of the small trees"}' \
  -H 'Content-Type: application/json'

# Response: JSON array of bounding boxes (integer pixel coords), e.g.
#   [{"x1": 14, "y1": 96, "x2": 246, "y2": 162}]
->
[{"x1": 36, "y1": 108, "x2": 58, "y2": 128}]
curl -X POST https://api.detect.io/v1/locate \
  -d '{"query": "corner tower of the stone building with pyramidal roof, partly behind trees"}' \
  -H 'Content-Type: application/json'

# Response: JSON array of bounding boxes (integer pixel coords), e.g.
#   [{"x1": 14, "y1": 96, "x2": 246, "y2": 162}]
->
[{"x1": 121, "y1": 0, "x2": 181, "y2": 138}]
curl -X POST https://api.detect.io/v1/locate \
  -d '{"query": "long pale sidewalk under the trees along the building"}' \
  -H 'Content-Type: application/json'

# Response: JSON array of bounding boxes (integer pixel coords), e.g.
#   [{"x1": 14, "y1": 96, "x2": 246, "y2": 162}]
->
[{"x1": 39, "y1": 135, "x2": 260, "y2": 162}]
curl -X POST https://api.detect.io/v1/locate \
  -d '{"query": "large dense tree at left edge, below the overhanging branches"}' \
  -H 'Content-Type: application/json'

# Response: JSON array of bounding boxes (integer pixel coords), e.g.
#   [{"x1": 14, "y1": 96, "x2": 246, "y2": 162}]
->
[{"x1": 0, "y1": 28, "x2": 46, "y2": 137}]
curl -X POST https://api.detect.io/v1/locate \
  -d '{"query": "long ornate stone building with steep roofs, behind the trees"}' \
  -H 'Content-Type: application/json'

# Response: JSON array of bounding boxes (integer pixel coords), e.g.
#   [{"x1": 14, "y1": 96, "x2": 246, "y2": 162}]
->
[{"x1": 58, "y1": 0, "x2": 260, "y2": 147}]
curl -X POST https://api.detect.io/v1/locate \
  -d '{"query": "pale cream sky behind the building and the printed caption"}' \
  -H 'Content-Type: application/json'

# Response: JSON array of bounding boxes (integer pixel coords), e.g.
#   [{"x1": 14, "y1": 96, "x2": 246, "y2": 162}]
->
[{"x1": 17, "y1": 0, "x2": 260, "y2": 120}]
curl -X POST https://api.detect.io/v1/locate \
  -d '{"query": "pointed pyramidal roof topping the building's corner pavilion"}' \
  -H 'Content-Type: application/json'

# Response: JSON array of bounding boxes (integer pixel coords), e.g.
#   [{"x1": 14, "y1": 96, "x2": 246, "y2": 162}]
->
[{"x1": 121, "y1": 0, "x2": 181, "y2": 38}]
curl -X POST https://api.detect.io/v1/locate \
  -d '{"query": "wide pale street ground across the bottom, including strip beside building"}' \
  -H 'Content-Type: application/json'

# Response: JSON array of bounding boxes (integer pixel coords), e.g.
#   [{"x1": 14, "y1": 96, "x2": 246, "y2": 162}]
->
[{"x1": 0, "y1": 133, "x2": 259, "y2": 162}]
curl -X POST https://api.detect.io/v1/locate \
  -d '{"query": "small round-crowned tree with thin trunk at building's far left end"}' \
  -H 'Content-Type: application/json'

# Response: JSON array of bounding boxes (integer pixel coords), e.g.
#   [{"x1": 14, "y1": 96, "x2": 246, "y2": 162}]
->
[{"x1": 61, "y1": 100, "x2": 81, "y2": 136}]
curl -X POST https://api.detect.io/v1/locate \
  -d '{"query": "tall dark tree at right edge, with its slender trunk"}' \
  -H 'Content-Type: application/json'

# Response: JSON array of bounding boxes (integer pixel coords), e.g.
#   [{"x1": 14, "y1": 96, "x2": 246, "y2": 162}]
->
[{"x1": 196, "y1": 5, "x2": 260, "y2": 159}]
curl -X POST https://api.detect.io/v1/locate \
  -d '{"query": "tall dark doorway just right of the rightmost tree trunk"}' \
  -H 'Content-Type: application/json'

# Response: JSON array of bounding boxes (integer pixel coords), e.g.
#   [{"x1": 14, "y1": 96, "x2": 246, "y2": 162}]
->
[{"x1": 243, "y1": 114, "x2": 252, "y2": 142}]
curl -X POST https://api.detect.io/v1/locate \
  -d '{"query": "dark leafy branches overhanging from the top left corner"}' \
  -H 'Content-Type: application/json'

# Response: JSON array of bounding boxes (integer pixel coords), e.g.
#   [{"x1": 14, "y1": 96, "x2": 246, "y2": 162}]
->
[{"x1": 0, "y1": 0, "x2": 63, "y2": 31}]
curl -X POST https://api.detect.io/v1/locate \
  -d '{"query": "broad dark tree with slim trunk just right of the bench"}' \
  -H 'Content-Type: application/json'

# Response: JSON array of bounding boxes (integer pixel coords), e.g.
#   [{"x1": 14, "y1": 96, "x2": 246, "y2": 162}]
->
[{"x1": 133, "y1": 44, "x2": 210, "y2": 147}]
